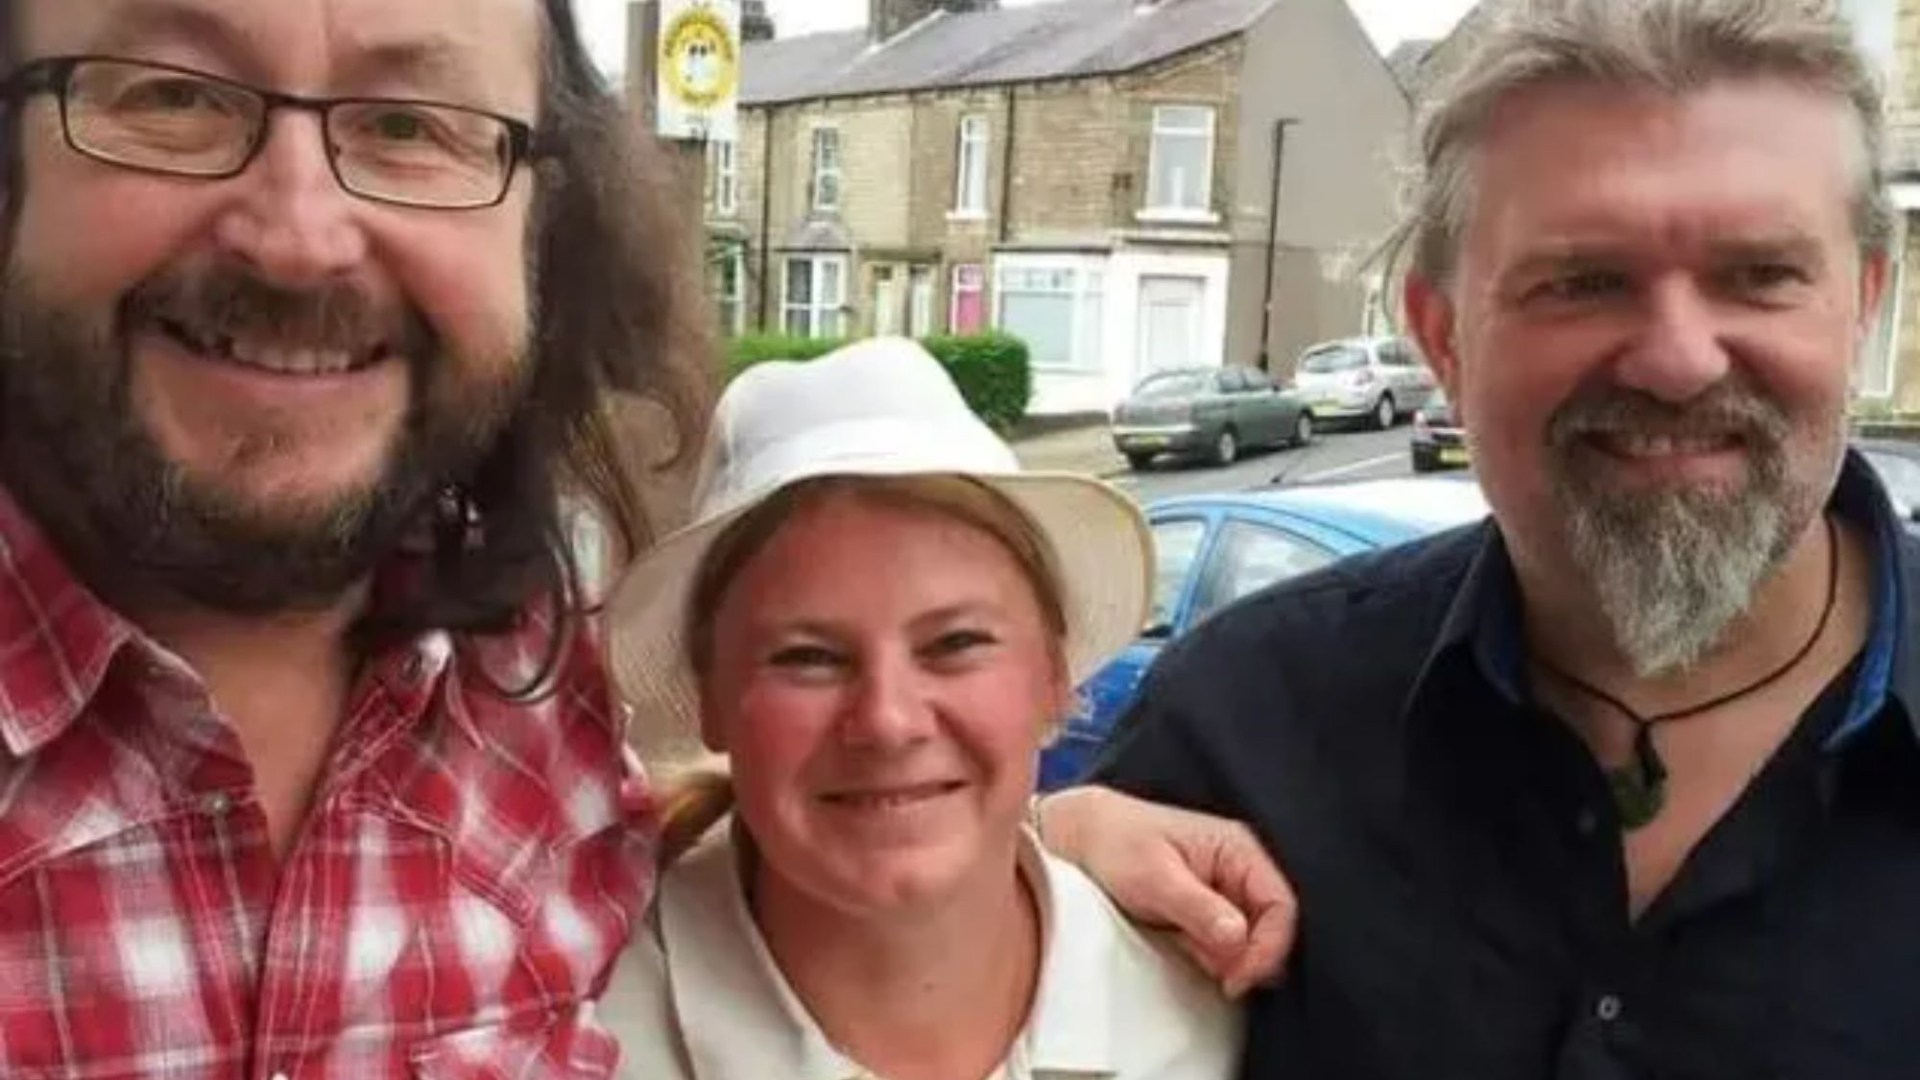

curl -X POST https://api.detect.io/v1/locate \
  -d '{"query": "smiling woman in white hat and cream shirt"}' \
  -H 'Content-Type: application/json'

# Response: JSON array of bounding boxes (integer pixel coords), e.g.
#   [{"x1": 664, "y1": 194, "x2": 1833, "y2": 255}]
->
[{"x1": 601, "y1": 340, "x2": 1238, "y2": 1080}]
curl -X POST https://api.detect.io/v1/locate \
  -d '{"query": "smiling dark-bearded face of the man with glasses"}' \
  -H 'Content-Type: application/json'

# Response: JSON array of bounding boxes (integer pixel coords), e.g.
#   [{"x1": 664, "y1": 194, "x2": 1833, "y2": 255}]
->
[{"x1": 0, "y1": 0, "x2": 541, "y2": 609}]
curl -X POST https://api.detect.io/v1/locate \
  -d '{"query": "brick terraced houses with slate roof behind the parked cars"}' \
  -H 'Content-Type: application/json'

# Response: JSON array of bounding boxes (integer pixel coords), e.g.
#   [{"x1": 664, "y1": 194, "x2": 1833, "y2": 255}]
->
[{"x1": 707, "y1": 0, "x2": 1411, "y2": 413}]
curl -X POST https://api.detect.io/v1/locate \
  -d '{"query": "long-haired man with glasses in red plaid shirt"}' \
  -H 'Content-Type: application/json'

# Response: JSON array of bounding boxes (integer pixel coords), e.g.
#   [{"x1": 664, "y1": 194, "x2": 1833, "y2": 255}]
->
[{"x1": 0, "y1": 0, "x2": 703, "y2": 1078}]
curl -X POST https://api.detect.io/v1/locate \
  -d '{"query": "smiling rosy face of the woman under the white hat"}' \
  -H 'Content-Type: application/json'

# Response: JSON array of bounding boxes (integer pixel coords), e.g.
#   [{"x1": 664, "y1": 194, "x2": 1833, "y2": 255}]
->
[{"x1": 703, "y1": 492, "x2": 1068, "y2": 917}]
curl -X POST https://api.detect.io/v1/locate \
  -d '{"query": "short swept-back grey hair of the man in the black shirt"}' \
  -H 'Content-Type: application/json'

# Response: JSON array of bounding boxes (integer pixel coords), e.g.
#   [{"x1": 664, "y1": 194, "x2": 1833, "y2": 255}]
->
[{"x1": 1392, "y1": 0, "x2": 1895, "y2": 284}]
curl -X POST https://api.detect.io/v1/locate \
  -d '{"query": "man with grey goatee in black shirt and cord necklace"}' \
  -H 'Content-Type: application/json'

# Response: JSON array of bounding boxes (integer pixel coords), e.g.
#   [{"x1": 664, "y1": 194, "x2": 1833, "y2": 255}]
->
[{"x1": 1039, "y1": 0, "x2": 1920, "y2": 1080}]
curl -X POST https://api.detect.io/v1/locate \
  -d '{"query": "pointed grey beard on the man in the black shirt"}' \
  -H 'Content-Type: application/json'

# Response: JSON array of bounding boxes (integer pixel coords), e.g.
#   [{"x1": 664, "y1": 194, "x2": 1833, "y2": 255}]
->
[{"x1": 1563, "y1": 479, "x2": 1793, "y2": 678}]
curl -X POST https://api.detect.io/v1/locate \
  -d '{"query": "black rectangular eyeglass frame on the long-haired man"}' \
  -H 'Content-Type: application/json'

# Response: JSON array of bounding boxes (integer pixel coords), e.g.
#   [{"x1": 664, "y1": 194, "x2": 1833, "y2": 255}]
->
[{"x1": 0, "y1": 54, "x2": 551, "y2": 211}]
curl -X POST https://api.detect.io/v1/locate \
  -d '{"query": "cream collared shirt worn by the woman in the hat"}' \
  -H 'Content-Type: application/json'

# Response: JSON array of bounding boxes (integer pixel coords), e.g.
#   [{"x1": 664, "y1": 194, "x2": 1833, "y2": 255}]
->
[{"x1": 599, "y1": 826, "x2": 1240, "y2": 1080}]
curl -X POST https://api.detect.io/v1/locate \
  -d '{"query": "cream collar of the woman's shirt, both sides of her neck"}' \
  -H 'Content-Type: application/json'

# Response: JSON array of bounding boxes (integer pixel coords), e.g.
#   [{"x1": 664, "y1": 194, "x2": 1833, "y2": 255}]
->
[{"x1": 659, "y1": 826, "x2": 1119, "y2": 1080}]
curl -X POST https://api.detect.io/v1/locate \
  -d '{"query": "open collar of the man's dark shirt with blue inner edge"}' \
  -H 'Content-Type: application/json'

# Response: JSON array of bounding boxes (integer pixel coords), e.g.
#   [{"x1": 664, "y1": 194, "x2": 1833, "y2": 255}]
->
[{"x1": 1404, "y1": 450, "x2": 1920, "y2": 749}]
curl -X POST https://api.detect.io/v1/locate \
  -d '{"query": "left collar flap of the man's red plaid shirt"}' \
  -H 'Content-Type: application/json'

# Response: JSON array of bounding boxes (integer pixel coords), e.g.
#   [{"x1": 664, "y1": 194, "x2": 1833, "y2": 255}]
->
[{"x1": 0, "y1": 486, "x2": 140, "y2": 757}]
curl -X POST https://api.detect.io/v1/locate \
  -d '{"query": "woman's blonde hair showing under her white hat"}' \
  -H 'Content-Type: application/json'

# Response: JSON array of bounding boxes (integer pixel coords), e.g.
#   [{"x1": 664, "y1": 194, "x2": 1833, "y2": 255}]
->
[{"x1": 659, "y1": 475, "x2": 1068, "y2": 867}]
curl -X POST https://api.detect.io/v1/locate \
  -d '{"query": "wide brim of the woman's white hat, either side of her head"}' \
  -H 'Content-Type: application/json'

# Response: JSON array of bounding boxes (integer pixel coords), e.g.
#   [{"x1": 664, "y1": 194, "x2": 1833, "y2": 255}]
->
[{"x1": 607, "y1": 473, "x2": 1154, "y2": 748}]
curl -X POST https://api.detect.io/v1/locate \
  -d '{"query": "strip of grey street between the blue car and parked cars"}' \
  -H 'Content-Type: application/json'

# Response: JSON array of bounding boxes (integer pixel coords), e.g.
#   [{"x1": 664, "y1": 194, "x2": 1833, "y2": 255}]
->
[{"x1": 1114, "y1": 425, "x2": 1413, "y2": 503}]
